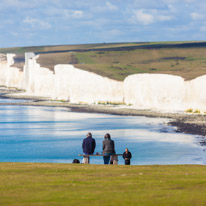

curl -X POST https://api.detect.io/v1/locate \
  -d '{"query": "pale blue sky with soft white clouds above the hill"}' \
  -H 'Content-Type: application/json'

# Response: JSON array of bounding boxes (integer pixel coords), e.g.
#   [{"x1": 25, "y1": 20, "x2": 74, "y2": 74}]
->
[{"x1": 0, "y1": 0, "x2": 206, "y2": 48}]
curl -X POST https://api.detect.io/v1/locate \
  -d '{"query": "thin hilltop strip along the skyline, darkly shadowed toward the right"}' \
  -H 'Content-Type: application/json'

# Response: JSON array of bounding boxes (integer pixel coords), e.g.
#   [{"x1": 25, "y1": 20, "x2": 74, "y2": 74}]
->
[{"x1": 0, "y1": 42, "x2": 206, "y2": 54}]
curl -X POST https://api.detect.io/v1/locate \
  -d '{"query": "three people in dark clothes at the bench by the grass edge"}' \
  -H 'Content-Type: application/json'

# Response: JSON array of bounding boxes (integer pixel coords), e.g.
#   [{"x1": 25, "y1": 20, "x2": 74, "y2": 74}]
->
[{"x1": 82, "y1": 132, "x2": 132, "y2": 165}]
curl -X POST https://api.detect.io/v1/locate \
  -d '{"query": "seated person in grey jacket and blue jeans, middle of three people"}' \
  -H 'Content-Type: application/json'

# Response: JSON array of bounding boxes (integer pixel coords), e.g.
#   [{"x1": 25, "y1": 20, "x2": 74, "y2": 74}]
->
[{"x1": 102, "y1": 133, "x2": 115, "y2": 164}]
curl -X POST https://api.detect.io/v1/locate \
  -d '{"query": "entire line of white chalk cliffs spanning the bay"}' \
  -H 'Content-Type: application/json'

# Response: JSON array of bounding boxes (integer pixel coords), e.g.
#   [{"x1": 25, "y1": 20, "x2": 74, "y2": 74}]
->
[{"x1": 0, "y1": 53, "x2": 206, "y2": 112}]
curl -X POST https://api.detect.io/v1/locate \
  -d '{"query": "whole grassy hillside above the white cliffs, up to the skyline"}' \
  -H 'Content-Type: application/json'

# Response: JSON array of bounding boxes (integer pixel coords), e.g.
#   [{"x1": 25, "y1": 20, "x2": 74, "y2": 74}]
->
[{"x1": 0, "y1": 42, "x2": 206, "y2": 80}]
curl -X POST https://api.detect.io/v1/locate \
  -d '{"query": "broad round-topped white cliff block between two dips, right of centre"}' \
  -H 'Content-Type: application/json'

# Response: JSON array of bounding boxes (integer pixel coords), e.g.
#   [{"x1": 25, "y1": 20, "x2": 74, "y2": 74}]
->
[{"x1": 124, "y1": 74, "x2": 185, "y2": 110}]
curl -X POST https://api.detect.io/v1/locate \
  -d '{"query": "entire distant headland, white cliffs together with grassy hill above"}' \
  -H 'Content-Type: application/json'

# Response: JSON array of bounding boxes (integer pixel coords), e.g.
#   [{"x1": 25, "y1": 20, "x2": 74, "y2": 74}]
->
[{"x1": 0, "y1": 42, "x2": 206, "y2": 115}]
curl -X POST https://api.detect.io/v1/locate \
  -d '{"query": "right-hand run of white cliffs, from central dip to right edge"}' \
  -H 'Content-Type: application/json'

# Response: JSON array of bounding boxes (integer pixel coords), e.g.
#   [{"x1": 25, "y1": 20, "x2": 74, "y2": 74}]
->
[{"x1": 124, "y1": 74, "x2": 206, "y2": 112}]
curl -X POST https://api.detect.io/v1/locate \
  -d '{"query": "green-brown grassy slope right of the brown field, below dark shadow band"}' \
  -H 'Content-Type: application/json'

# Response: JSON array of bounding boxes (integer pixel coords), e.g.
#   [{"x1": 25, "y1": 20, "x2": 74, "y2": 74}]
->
[{"x1": 75, "y1": 48, "x2": 206, "y2": 80}]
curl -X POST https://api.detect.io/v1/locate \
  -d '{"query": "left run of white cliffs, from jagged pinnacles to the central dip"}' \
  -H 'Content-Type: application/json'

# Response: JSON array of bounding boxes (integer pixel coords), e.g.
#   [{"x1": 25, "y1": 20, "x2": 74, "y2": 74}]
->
[{"x1": 0, "y1": 53, "x2": 124, "y2": 104}]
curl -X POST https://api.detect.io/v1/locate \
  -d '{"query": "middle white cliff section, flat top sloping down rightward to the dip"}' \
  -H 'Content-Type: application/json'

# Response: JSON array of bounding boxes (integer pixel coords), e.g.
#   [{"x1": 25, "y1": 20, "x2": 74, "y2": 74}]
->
[{"x1": 55, "y1": 65, "x2": 123, "y2": 104}]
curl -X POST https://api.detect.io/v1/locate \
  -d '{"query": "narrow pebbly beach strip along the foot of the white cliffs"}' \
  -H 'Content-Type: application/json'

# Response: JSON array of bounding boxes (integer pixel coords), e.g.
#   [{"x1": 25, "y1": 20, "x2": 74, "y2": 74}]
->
[{"x1": 0, "y1": 88, "x2": 206, "y2": 137}]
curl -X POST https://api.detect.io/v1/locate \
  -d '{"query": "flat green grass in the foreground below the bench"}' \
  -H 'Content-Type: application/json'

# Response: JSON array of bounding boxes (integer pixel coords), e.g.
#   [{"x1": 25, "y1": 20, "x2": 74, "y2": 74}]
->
[{"x1": 0, "y1": 163, "x2": 206, "y2": 206}]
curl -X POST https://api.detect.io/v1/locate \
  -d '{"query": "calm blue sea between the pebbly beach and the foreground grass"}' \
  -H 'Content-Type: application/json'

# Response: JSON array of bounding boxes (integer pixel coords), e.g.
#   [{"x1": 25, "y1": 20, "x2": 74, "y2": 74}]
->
[{"x1": 0, "y1": 99, "x2": 206, "y2": 165}]
